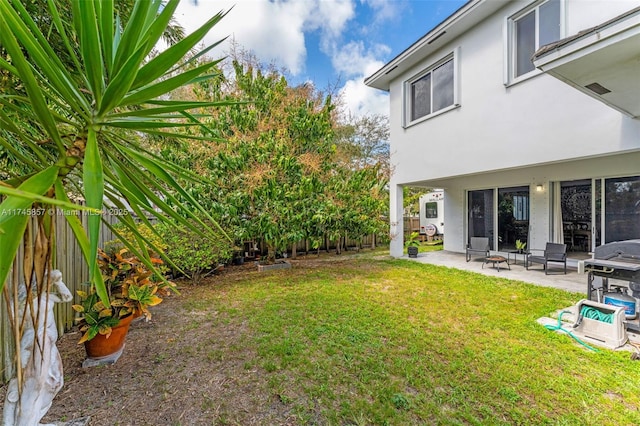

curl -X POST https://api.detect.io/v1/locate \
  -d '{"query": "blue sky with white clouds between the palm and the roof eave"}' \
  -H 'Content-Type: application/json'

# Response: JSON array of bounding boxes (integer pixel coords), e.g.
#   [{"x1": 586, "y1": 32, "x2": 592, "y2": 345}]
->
[{"x1": 176, "y1": 0, "x2": 466, "y2": 115}]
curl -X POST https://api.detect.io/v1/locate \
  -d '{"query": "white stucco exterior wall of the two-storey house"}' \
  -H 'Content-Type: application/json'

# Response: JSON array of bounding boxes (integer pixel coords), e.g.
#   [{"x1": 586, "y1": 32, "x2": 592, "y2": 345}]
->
[{"x1": 389, "y1": 0, "x2": 640, "y2": 255}]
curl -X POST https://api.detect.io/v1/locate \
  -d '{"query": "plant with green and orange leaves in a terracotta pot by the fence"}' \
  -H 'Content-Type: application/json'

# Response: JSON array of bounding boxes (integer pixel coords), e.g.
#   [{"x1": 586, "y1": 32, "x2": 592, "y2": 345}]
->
[{"x1": 73, "y1": 248, "x2": 175, "y2": 359}]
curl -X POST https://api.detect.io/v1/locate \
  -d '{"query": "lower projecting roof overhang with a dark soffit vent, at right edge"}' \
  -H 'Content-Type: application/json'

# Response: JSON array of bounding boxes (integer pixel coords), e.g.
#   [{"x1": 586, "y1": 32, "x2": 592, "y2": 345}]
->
[{"x1": 533, "y1": 7, "x2": 640, "y2": 118}]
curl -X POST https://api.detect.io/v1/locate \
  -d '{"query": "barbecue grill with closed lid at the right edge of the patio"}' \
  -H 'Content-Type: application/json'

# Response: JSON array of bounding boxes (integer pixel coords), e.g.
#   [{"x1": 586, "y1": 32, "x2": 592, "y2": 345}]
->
[{"x1": 584, "y1": 239, "x2": 640, "y2": 331}]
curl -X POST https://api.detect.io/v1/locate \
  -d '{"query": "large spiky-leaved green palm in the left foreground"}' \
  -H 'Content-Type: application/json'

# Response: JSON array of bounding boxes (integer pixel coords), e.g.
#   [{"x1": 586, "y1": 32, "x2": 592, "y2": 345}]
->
[{"x1": 0, "y1": 0, "x2": 230, "y2": 420}]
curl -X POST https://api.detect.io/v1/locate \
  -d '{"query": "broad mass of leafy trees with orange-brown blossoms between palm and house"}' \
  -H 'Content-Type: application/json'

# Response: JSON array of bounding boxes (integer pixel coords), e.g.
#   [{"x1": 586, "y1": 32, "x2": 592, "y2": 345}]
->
[{"x1": 152, "y1": 49, "x2": 388, "y2": 257}]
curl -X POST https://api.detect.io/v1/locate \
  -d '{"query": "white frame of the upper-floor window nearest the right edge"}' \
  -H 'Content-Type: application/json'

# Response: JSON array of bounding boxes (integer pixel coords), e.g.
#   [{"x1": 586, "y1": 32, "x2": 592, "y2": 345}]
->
[{"x1": 504, "y1": 0, "x2": 566, "y2": 86}]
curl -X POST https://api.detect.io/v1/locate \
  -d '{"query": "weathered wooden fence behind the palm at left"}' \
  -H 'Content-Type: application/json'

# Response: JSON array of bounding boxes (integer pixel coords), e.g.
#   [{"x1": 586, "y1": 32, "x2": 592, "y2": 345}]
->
[{"x1": 0, "y1": 211, "x2": 117, "y2": 381}]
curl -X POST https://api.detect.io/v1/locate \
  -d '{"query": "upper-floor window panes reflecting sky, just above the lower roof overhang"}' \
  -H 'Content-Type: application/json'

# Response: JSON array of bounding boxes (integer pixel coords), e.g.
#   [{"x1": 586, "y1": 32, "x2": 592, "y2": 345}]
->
[{"x1": 509, "y1": 0, "x2": 562, "y2": 81}]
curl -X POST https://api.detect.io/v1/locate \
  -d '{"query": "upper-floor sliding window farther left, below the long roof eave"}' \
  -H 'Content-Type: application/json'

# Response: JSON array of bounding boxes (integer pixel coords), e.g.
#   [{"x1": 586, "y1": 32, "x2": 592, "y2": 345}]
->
[{"x1": 407, "y1": 54, "x2": 456, "y2": 122}]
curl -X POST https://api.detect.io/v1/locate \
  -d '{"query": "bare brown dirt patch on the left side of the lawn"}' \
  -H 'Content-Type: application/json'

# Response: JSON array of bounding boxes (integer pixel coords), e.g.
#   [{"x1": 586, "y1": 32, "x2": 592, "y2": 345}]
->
[{"x1": 0, "y1": 254, "x2": 380, "y2": 426}]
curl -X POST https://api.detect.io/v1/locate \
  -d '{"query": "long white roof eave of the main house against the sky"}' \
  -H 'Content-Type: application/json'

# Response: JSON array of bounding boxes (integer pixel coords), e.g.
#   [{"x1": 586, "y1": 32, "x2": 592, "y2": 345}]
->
[{"x1": 364, "y1": 0, "x2": 505, "y2": 91}]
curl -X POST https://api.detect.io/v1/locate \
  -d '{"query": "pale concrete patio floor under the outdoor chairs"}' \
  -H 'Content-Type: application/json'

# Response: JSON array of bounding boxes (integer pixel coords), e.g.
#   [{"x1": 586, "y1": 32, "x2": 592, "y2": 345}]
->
[{"x1": 405, "y1": 250, "x2": 587, "y2": 297}]
